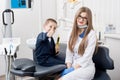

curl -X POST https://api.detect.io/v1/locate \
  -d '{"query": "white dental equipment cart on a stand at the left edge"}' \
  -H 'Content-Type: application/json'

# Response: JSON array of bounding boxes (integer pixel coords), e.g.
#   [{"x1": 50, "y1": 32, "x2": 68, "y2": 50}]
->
[{"x1": 0, "y1": 38, "x2": 20, "y2": 80}]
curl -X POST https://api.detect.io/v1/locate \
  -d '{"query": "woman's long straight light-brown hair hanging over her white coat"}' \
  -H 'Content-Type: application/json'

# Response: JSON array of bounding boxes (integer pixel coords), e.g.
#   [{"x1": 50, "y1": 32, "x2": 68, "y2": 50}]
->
[{"x1": 68, "y1": 7, "x2": 93, "y2": 55}]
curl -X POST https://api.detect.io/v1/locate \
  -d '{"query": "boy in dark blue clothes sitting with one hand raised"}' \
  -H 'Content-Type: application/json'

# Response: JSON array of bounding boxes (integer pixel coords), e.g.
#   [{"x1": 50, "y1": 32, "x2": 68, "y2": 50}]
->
[{"x1": 34, "y1": 18, "x2": 64, "y2": 66}]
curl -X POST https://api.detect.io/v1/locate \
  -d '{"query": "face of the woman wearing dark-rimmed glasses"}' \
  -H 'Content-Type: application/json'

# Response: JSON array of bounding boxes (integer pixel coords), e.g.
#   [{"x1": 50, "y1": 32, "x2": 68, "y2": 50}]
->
[{"x1": 77, "y1": 12, "x2": 87, "y2": 26}]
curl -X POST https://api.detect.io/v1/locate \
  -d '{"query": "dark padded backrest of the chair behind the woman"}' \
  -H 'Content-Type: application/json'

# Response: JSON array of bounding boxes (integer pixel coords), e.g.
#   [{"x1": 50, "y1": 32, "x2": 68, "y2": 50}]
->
[{"x1": 93, "y1": 46, "x2": 114, "y2": 69}]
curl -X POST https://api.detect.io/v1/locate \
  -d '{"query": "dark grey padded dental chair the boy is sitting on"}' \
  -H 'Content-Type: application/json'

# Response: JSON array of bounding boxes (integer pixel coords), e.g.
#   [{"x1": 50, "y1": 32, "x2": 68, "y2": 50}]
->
[{"x1": 10, "y1": 44, "x2": 66, "y2": 80}]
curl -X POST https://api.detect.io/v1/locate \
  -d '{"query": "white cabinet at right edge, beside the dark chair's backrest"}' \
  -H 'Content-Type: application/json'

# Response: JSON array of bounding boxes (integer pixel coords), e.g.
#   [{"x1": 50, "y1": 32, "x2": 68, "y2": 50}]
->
[{"x1": 105, "y1": 34, "x2": 120, "y2": 80}]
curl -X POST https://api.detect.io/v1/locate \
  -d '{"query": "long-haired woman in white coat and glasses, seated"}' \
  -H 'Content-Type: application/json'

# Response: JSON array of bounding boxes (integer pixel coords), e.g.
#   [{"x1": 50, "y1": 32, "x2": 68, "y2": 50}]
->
[{"x1": 58, "y1": 7, "x2": 97, "y2": 80}]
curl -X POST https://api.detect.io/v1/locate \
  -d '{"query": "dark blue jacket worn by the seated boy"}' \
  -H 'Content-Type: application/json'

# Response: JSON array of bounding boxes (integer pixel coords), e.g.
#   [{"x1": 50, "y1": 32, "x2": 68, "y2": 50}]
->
[{"x1": 34, "y1": 32, "x2": 55, "y2": 65}]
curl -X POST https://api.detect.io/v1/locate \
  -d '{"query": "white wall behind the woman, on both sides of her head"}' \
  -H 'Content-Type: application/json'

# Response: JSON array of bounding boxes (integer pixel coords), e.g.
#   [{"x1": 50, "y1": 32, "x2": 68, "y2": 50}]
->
[{"x1": 57, "y1": 0, "x2": 120, "y2": 38}]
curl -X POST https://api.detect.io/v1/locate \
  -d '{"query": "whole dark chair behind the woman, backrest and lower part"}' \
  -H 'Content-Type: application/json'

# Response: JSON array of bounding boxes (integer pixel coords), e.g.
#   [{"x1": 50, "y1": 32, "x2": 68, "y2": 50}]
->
[{"x1": 93, "y1": 46, "x2": 114, "y2": 80}]
